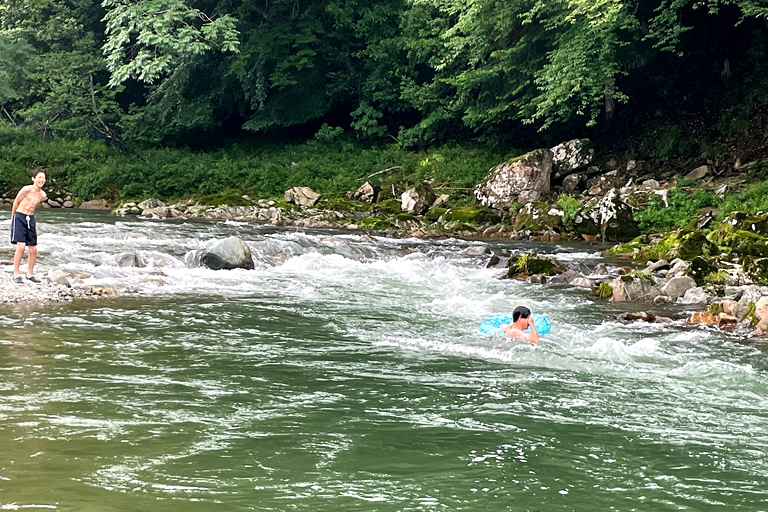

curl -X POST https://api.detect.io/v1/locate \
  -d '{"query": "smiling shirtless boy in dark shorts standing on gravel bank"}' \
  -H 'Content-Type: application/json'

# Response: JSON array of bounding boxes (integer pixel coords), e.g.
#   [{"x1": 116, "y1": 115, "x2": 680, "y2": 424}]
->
[{"x1": 11, "y1": 169, "x2": 48, "y2": 284}]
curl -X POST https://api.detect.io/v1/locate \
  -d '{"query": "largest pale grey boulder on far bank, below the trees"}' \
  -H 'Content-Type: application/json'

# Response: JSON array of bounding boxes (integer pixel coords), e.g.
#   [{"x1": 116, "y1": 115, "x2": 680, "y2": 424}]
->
[{"x1": 475, "y1": 149, "x2": 552, "y2": 209}]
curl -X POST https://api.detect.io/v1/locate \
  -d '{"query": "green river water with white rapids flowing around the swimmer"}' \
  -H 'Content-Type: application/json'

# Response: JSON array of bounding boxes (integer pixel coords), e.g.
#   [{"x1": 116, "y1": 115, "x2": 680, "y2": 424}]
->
[{"x1": 0, "y1": 210, "x2": 768, "y2": 512}]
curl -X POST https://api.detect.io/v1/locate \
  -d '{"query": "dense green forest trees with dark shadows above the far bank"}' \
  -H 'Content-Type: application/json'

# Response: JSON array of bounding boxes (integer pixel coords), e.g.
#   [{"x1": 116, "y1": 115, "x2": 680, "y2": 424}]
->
[{"x1": 0, "y1": 0, "x2": 768, "y2": 202}]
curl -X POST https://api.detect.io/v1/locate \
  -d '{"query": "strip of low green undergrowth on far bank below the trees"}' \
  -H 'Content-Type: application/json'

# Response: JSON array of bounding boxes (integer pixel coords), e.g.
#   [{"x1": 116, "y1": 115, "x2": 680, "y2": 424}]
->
[{"x1": 0, "y1": 125, "x2": 508, "y2": 200}]
